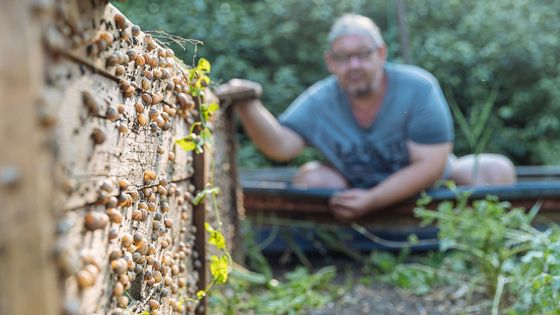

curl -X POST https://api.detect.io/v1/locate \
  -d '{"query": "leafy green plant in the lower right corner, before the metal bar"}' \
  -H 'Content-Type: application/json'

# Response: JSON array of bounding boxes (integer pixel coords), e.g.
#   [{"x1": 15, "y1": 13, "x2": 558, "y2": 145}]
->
[{"x1": 414, "y1": 195, "x2": 560, "y2": 314}]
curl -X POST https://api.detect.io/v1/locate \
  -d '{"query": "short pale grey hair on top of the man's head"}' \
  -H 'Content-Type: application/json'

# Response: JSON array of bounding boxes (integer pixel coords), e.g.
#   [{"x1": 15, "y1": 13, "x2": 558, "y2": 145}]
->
[{"x1": 328, "y1": 13, "x2": 385, "y2": 47}]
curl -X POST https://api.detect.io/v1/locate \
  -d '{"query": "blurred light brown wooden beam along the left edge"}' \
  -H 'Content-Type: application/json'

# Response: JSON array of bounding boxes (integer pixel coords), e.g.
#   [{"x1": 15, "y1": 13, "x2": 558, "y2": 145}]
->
[{"x1": 0, "y1": 0, "x2": 62, "y2": 315}]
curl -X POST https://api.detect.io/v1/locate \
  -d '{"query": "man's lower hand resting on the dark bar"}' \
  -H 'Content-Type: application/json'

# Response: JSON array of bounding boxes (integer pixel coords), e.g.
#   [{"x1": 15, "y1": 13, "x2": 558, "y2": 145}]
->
[{"x1": 329, "y1": 188, "x2": 372, "y2": 221}]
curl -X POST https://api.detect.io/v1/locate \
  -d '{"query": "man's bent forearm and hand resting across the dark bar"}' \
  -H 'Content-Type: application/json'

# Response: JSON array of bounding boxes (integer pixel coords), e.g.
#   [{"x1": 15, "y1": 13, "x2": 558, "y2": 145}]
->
[{"x1": 330, "y1": 141, "x2": 452, "y2": 221}]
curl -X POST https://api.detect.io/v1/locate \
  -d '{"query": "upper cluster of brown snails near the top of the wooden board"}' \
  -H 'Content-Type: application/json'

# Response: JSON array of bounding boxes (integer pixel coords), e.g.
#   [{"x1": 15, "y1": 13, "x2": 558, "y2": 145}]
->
[{"x1": 83, "y1": 13, "x2": 201, "y2": 144}]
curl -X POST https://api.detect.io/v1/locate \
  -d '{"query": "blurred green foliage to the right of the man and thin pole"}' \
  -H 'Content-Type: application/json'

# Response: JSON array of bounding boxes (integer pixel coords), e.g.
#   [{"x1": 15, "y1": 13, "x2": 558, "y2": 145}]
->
[{"x1": 408, "y1": 0, "x2": 560, "y2": 164}]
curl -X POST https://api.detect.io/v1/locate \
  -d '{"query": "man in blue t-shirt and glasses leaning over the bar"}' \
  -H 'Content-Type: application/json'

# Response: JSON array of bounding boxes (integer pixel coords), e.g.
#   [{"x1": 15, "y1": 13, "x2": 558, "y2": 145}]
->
[{"x1": 218, "y1": 14, "x2": 515, "y2": 221}]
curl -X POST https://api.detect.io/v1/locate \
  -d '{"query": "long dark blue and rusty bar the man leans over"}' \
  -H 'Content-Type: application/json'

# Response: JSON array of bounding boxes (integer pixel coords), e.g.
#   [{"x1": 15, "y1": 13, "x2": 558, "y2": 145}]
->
[{"x1": 242, "y1": 170, "x2": 560, "y2": 228}]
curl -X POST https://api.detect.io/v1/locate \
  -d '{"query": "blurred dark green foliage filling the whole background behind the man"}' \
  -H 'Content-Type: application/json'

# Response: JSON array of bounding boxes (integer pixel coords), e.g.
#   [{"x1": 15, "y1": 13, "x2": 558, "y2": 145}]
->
[{"x1": 114, "y1": 0, "x2": 560, "y2": 167}]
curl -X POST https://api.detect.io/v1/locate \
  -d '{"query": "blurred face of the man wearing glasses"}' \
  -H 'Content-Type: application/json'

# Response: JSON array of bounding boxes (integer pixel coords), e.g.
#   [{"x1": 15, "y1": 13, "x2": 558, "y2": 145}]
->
[{"x1": 325, "y1": 35, "x2": 386, "y2": 97}]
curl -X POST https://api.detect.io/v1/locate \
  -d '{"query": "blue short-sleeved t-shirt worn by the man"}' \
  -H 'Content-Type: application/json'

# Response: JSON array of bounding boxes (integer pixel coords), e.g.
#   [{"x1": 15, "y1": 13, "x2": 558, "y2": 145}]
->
[{"x1": 279, "y1": 63, "x2": 454, "y2": 188}]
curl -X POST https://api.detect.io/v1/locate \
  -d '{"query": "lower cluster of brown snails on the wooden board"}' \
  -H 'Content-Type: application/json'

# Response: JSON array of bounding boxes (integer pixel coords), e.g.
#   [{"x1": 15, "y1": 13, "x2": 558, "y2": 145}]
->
[{"x1": 76, "y1": 170, "x2": 200, "y2": 314}]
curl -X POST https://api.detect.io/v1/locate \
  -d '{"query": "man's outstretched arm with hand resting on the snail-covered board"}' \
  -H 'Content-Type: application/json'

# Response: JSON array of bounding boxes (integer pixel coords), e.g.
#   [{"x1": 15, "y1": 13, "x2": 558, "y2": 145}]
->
[{"x1": 218, "y1": 79, "x2": 305, "y2": 161}]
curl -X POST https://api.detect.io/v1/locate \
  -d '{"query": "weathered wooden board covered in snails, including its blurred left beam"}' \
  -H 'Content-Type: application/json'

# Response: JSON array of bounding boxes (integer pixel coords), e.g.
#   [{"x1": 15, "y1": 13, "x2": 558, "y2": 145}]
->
[{"x1": 0, "y1": 0, "x2": 233, "y2": 314}]
